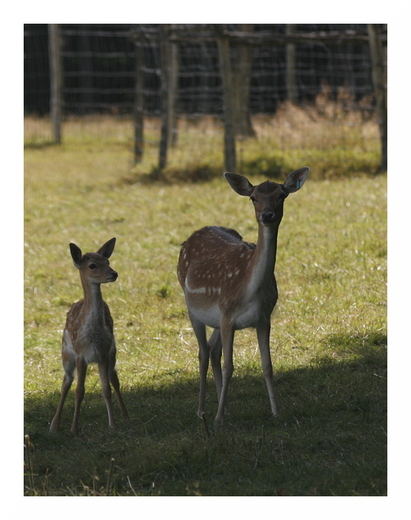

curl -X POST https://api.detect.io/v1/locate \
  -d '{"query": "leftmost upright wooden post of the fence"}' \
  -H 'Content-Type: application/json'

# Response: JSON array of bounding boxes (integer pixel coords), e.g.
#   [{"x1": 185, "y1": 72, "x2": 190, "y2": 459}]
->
[{"x1": 48, "y1": 24, "x2": 63, "y2": 144}]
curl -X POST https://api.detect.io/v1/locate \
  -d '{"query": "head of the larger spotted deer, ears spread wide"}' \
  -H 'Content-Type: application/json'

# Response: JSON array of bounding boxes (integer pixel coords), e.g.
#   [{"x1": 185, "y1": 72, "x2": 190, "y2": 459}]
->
[{"x1": 224, "y1": 167, "x2": 310, "y2": 227}]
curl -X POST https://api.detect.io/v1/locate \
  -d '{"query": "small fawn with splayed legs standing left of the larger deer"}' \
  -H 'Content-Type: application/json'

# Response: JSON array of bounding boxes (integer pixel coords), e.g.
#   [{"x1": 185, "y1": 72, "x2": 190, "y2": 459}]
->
[{"x1": 50, "y1": 238, "x2": 128, "y2": 435}]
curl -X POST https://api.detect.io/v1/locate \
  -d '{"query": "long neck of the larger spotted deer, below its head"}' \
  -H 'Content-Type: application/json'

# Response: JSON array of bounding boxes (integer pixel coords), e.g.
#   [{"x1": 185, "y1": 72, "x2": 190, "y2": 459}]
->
[{"x1": 251, "y1": 223, "x2": 278, "y2": 290}]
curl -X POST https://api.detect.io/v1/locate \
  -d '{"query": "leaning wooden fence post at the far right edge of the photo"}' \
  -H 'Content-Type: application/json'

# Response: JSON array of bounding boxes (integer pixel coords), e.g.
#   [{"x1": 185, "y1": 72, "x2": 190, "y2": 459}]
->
[{"x1": 368, "y1": 24, "x2": 387, "y2": 171}]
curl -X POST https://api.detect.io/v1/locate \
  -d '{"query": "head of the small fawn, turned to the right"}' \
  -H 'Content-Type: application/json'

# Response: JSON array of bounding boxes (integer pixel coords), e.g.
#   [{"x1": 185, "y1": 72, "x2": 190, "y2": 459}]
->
[{"x1": 70, "y1": 238, "x2": 118, "y2": 284}]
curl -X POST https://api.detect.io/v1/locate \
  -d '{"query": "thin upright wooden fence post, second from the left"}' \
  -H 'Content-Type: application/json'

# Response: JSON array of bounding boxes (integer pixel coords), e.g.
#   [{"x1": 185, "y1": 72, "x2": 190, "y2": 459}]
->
[{"x1": 134, "y1": 41, "x2": 144, "y2": 164}]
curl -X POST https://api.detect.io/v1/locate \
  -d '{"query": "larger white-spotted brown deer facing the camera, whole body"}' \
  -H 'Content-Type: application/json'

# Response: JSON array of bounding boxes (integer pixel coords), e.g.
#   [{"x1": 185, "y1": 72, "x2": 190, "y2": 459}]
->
[{"x1": 177, "y1": 167, "x2": 309, "y2": 423}]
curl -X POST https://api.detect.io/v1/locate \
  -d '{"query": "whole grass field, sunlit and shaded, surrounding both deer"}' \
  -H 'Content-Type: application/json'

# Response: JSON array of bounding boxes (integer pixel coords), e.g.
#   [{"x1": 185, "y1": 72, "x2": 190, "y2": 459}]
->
[{"x1": 24, "y1": 112, "x2": 387, "y2": 496}]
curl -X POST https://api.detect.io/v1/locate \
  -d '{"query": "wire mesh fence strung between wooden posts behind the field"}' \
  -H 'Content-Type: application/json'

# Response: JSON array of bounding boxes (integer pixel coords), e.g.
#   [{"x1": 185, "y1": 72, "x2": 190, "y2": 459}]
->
[{"x1": 24, "y1": 24, "x2": 386, "y2": 176}]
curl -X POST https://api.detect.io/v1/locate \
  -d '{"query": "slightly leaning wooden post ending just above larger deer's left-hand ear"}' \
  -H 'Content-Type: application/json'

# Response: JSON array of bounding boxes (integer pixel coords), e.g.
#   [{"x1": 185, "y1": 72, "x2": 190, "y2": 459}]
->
[{"x1": 216, "y1": 25, "x2": 236, "y2": 172}]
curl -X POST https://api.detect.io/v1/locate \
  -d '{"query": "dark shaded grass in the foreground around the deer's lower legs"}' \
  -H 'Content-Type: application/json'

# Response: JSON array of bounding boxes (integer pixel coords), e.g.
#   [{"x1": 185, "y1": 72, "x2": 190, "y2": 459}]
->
[{"x1": 25, "y1": 333, "x2": 386, "y2": 496}]
